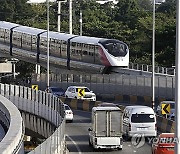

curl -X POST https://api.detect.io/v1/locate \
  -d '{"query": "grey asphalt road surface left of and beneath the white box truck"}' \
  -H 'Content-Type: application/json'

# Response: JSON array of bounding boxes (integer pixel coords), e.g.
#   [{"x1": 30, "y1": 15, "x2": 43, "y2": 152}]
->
[{"x1": 66, "y1": 110, "x2": 151, "y2": 154}]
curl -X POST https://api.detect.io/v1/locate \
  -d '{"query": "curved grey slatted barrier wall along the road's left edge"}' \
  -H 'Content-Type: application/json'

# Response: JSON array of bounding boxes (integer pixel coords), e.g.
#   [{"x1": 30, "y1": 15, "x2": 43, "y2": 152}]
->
[{"x1": 0, "y1": 84, "x2": 65, "y2": 154}]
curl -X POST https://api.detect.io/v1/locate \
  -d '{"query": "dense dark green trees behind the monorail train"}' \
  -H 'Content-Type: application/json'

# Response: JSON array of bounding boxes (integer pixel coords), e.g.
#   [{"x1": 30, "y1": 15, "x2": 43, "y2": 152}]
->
[{"x1": 0, "y1": 0, "x2": 176, "y2": 67}]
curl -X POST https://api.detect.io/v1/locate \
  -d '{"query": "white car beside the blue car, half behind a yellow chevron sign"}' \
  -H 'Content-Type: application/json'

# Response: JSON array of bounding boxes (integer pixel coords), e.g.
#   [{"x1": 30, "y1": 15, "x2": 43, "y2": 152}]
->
[{"x1": 65, "y1": 86, "x2": 96, "y2": 101}]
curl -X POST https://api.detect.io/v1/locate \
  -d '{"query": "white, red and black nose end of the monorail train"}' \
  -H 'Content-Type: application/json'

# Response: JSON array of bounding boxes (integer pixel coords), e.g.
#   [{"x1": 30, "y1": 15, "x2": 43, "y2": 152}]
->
[{"x1": 98, "y1": 39, "x2": 129, "y2": 67}]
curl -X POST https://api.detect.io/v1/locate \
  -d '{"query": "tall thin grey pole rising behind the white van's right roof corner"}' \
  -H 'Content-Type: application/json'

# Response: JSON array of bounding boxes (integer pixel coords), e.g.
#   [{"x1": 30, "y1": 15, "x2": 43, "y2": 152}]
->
[{"x1": 152, "y1": 0, "x2": 156, "y2": 110}]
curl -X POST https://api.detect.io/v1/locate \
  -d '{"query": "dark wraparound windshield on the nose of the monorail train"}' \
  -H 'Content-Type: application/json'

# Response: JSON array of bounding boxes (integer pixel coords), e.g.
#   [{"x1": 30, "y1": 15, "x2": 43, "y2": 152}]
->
[{"x1": 99, "y1": 40, "x2": 128, "y2": 57}]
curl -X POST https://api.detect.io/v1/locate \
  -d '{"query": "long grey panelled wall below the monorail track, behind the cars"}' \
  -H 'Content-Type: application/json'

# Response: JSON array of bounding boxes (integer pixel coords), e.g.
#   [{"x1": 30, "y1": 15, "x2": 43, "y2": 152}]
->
[{"x1": 31, "y1": 74, "x2": 175, "y2": 100}]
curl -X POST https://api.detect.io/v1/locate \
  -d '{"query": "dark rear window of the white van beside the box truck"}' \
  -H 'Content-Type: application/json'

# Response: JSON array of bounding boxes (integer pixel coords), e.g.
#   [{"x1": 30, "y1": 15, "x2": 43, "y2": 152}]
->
[{"x1": 131, "y1": 114, "x2": 155, "y2": 123}]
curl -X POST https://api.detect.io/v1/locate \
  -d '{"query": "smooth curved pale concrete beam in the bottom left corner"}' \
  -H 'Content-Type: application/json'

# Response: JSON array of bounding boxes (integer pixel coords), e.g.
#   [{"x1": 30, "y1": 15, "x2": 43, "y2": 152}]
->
[{"x1": 0, "y1": 95, "x2": 25, "y2": 154}]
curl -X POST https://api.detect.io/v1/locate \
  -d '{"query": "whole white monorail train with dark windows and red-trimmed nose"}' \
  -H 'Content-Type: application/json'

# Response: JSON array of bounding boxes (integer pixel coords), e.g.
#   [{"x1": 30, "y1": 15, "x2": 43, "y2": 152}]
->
[{"x1": 0, "y1": 21, "x2": 129, "y2": 72}]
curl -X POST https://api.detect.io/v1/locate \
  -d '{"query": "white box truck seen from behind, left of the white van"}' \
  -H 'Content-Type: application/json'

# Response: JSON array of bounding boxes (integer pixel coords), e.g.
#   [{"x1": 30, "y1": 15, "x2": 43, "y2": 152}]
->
[{"x1": 88, "y1": 107, "x2": 123, "y2": 150}]
